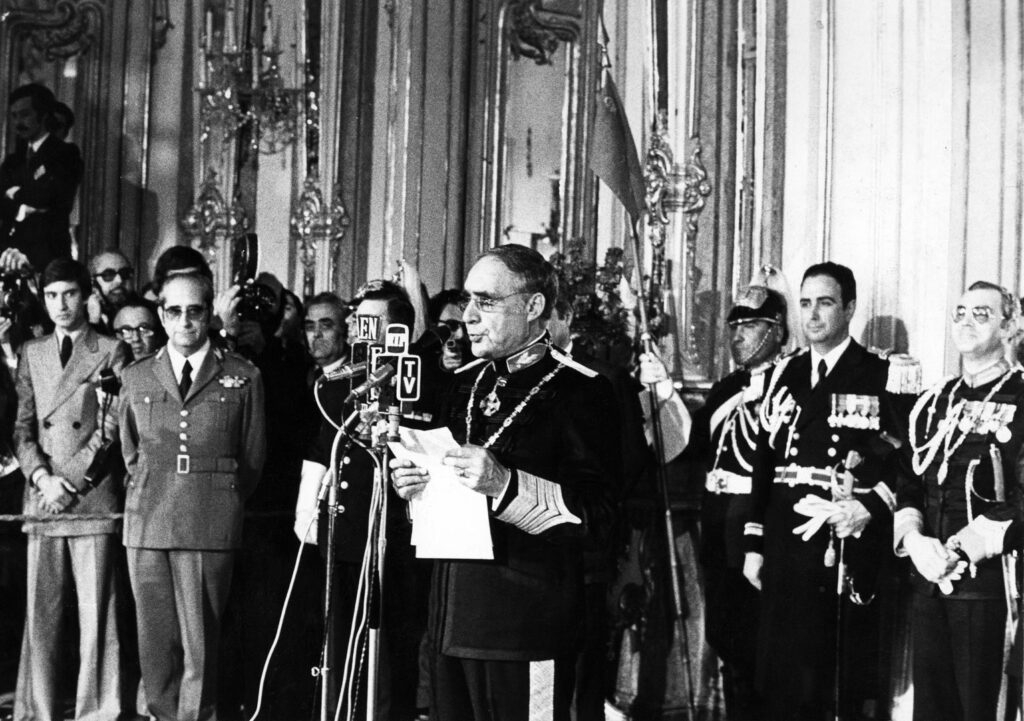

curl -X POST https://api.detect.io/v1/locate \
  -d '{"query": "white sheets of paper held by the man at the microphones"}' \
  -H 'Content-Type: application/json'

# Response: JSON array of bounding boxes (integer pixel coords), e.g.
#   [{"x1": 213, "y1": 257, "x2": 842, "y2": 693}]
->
[{"x1": 388, "y1": 428, "x2": 495, "y2": 560}]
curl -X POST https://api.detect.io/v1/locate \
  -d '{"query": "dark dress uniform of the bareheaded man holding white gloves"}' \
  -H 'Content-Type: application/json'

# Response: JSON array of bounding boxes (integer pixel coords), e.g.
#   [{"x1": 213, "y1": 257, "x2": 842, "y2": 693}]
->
[{"x1": 744, "y1": 340, "x2": 905, "y2": 719}]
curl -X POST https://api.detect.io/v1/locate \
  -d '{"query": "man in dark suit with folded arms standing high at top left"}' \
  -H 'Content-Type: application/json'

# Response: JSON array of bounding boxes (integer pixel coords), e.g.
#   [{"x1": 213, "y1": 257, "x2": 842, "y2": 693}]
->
[{"x1": 0, "y1": 84, "x2": 82, "y2": 272}]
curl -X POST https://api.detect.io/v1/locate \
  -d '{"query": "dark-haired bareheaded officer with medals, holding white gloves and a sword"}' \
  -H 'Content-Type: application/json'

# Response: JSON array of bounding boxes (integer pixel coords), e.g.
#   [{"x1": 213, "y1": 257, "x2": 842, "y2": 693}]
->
[{"x1": 743, "y1": 262, "x2": 916, "y2": 721}]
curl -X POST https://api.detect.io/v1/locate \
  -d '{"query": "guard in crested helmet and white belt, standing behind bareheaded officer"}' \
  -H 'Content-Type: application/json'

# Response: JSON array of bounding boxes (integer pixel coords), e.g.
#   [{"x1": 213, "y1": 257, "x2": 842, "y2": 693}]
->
[{"x1": 686, "y1": 286, "x2": 788, "y2": 720}]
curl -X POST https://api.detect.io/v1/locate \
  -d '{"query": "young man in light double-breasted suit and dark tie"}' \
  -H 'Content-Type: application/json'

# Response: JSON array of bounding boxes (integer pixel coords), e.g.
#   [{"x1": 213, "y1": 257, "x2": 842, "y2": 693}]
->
[{"x1": 14, "y1": 258, "x2": 125, "y2": 721}]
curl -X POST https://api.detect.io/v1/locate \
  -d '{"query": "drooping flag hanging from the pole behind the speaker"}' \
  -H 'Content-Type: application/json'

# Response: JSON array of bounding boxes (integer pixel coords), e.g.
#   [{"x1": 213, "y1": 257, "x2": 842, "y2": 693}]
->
[{"x1": 589, "y1": 67, "x2": 644, "y2": 224}]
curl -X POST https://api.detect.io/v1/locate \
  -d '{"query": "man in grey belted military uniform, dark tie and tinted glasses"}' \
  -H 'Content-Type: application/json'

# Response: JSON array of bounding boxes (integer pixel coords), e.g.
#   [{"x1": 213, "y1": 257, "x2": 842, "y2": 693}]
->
[{"x1": 120, "y1": 274, "x2": 266, "y2": 721}]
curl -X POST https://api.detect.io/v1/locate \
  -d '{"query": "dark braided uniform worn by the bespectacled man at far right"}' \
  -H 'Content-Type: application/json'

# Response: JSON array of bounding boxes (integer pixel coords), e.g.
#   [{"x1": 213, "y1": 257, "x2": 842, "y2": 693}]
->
[{"x1": 894, "y1": 364, "x2": 1024, "y2": 721}]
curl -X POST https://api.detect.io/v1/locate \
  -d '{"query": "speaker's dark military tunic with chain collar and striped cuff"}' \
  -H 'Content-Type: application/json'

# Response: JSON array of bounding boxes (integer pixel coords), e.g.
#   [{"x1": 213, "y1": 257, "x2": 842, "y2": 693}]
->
[{"x1": 430, "y1": 346, "x2": 621, "y2": 661}]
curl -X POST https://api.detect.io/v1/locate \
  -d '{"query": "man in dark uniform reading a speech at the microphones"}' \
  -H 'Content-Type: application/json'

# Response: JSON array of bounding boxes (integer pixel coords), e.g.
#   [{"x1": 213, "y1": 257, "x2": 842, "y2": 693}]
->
[{"x1": 391, "y1": 246, "x2": 621, "y2": 721}]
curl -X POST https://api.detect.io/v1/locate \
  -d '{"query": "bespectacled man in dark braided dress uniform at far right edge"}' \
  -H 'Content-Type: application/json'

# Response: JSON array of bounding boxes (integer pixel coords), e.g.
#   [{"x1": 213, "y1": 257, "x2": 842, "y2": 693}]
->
[{"x1": 893, "y1": 282, "x2": 1024, "y2": 721}]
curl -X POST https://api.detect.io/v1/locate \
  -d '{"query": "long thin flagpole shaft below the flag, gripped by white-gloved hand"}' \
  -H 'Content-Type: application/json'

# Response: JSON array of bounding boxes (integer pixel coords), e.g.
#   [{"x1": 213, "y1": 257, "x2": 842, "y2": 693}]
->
[{"x1": 630, "y1": 210, "x2": 696, "y2": 721}]
